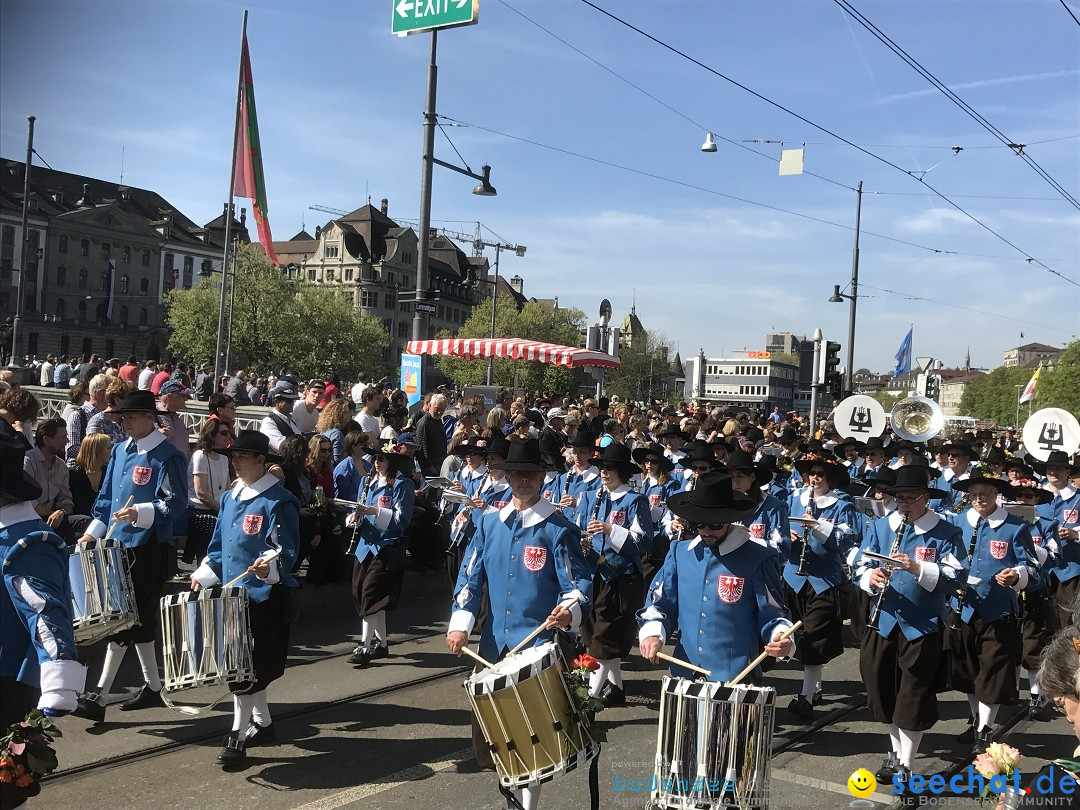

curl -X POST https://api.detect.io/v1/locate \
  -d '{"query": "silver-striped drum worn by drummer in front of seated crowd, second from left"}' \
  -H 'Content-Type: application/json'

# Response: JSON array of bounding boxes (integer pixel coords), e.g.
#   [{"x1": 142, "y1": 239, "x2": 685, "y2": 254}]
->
[{"x1": 161, "y1": 588, "x2": 255, "y2": 712}]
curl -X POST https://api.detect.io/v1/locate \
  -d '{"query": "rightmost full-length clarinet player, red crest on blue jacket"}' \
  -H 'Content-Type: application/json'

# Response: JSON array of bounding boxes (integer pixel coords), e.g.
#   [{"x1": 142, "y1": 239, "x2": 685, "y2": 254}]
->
[{"x1": 945, "y1": 475, "x2": 1035, "y2": 753}]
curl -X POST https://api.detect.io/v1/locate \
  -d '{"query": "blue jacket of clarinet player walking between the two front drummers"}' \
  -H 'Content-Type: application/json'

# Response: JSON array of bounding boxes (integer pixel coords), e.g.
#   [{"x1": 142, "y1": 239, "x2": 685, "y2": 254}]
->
[{"x1": 575, "y1": 484, "x2": 654, "y2": 582}]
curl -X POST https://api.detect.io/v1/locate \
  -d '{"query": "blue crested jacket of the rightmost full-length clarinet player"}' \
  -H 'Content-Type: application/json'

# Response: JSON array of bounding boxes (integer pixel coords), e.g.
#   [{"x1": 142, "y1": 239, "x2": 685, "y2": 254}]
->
[{"x1": 949, "y1": 507, "x2": 1035, "y2": 622}]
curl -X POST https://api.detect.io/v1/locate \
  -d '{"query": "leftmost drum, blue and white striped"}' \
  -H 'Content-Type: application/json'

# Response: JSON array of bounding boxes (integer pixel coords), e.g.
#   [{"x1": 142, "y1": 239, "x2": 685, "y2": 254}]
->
[{"x1": 68, "y1": 540, "x2": 138, "y2": 644}]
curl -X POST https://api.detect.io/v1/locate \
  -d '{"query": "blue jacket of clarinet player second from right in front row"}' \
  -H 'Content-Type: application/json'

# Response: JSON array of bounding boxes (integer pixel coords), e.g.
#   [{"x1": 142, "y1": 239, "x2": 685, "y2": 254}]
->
[{"x1": 855, "y1": 512, "x2": 966, "y2": 640}]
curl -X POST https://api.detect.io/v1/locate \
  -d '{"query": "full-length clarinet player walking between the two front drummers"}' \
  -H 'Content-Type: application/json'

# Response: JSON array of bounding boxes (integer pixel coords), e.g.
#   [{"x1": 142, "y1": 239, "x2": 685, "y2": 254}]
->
[{"x1": 576, "y1": 443, "x2": 653, "y2": 706}]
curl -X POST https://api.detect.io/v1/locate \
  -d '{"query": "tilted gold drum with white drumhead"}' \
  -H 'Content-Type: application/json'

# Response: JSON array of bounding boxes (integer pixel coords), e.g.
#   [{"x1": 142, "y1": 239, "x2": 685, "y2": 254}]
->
[{"x1": 464, "y1": 642, "x2": 600, "y2": 787}]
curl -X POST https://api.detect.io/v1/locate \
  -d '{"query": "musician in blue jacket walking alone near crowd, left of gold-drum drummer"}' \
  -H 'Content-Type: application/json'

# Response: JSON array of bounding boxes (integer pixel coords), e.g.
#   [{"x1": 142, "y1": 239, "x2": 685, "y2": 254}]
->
[{"x1": 346, "y1": 444, "x2": 416, "y2": 667}]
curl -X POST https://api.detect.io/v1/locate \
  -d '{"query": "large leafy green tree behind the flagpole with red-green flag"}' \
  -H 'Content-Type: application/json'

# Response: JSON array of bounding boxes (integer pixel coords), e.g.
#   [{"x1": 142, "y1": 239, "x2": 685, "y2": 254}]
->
[{"x1": 165, "y1": 245, "x2": 389, "y2": 377}]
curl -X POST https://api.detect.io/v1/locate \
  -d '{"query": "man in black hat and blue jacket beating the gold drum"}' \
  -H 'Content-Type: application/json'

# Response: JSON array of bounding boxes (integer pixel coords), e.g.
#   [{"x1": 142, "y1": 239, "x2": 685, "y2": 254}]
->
[{"x1": 446, "y1": 438, "x2": 593, "y2": 810}]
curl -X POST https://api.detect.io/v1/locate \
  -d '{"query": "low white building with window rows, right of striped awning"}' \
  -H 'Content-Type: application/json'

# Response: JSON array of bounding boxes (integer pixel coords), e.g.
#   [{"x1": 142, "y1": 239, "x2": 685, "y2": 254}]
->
[{"x1": 683, "y1": 352, "x2": 799, "y2": 411}]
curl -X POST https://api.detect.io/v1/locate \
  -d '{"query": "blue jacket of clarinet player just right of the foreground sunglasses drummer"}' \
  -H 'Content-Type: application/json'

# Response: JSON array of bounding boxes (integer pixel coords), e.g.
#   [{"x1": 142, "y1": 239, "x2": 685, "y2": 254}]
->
[{"x1": 784, "y1": 487, "x2": 861, "y2": 593}]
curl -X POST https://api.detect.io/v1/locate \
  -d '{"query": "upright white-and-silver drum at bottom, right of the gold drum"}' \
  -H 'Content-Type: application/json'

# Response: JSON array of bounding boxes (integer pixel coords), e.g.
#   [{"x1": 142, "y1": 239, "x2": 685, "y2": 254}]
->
[{"x1": 652, "y1": 677, "x2": 777, "y2": 810}]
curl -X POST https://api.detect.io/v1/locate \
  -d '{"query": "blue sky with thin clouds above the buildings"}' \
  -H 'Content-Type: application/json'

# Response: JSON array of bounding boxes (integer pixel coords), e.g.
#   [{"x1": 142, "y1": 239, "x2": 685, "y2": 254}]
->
[{"x1": 0, "y1": 0, "x2": 1080, "y2": 370}]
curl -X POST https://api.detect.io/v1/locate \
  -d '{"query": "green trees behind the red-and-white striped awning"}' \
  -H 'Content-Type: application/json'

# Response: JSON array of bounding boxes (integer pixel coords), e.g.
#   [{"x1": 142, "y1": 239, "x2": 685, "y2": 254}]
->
[{"x1": 434, "y1": 296, "x2": 585, "y2": 392}]
